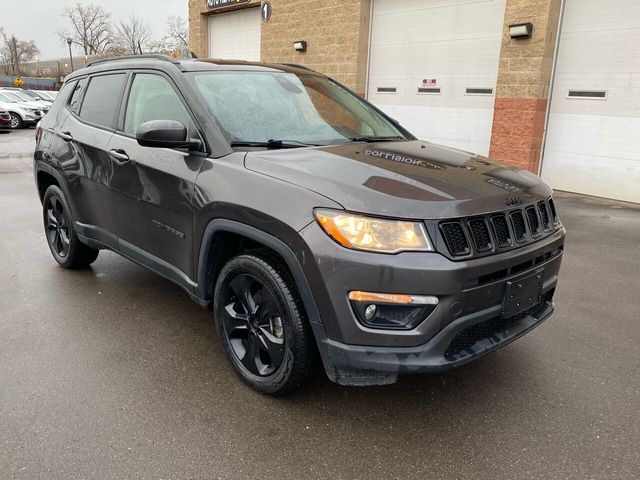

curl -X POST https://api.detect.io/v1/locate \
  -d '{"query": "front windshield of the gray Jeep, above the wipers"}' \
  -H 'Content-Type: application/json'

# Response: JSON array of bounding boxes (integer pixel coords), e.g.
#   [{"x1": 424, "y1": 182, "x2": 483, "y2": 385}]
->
[{"x1": 190, "y1": 71, "x2": 406, "y2": 146}]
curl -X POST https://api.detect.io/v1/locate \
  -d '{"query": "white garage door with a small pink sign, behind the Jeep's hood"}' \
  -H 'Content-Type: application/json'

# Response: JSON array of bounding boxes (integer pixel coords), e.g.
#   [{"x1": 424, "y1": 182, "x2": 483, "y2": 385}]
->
[{"x1": 367, "y1": 0, "x2": 505, "y2": 154}]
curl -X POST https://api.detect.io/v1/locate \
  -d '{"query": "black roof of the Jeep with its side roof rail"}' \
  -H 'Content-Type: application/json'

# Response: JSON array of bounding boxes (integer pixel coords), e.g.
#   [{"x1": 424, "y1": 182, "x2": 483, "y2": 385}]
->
[{"x1": 68, "y1": 55, "x2": 320, "y2": 78}]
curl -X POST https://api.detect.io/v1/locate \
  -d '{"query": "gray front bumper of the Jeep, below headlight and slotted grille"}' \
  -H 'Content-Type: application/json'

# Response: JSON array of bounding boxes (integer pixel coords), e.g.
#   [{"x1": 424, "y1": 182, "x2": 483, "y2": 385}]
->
[{"x1": 292, "y1": 223, "x2": 565, "y2": 385}]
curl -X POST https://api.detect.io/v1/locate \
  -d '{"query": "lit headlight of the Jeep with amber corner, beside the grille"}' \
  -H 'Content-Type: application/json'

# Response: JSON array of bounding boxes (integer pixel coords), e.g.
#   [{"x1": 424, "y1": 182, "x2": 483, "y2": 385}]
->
[{"x1": 315, "y1": 210, "x2": 433, "y2": 253}]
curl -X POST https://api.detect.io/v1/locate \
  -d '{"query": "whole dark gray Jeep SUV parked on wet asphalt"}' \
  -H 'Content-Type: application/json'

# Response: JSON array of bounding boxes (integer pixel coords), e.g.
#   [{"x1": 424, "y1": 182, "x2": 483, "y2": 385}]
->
[{"x1": 34, "y1": 56, "x2": 565, "y2": 394}]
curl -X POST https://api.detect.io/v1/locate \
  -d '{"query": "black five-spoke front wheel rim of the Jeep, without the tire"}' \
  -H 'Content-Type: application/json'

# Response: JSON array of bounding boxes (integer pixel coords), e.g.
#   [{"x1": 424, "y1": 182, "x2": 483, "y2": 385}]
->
[{"x1": 223, "y1": 274, "x2": 285, "y2": 377}]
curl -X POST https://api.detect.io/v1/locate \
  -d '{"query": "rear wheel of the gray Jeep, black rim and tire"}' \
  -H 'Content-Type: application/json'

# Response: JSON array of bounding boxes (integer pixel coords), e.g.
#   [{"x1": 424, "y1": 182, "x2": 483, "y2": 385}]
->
[{"x1": 42, "y1": 185, "x2": 100, "y2": 268}]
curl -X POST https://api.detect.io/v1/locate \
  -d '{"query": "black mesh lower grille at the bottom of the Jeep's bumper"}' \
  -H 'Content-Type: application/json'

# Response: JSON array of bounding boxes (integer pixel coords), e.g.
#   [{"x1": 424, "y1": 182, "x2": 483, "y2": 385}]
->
[{"x1": 444, "y1": 290, "x2": 554, "y2": 361}]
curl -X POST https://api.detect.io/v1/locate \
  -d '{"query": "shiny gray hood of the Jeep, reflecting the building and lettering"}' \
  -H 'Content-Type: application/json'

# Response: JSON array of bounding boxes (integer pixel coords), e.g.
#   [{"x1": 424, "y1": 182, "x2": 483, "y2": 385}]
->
[{"x1": 245, "y1": 140, "x2": 551, "y2": 219}]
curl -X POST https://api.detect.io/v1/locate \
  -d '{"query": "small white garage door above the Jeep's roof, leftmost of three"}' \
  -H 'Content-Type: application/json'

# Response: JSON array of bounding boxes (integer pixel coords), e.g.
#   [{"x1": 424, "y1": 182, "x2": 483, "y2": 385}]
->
[{"x1": 209, "y1": 8, "x2": 260, "y2": 62}]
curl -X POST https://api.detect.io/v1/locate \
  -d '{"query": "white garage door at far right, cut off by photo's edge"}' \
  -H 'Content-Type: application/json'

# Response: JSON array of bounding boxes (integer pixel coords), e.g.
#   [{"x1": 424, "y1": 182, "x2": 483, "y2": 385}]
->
[{"x1": 542, "y1": 0, "x2": 640, "y2": 202}]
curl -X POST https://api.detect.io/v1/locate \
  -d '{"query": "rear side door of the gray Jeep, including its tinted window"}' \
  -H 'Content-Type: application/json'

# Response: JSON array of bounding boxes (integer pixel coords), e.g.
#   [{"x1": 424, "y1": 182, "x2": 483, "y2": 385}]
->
[{"x1": 55, "y1": 72, "x2": 127, "y2": 246}]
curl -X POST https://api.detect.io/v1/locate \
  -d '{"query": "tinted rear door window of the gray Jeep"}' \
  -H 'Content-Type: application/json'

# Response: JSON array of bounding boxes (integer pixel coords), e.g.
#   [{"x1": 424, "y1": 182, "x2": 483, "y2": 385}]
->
[{"x1": 80, "y1": 73, "x2": 126, "y2": 127}]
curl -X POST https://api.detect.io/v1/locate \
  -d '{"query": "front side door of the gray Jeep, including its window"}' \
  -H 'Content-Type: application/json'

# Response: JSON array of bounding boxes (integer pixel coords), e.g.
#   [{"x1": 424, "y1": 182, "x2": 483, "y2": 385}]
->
[{"x1": 109, "y1": 71, "x2": 205, "y2": 285}]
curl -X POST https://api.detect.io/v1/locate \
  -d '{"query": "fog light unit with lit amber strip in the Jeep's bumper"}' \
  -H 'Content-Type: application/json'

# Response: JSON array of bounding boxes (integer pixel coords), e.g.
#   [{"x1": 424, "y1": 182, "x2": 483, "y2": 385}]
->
[{"x1": 349, "y1": 291, "x2": 438, "y2": 330}]
